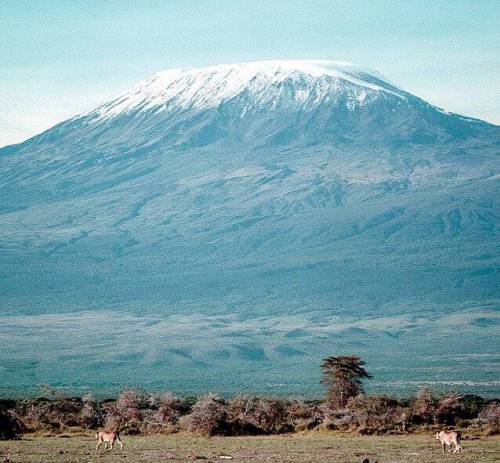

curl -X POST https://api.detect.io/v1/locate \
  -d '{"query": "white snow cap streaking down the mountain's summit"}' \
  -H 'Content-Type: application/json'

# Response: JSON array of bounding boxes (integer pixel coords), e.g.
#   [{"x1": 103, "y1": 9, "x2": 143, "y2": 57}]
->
[{"x1": 91, "y1": 60, "x2": 404, "y2": 119}]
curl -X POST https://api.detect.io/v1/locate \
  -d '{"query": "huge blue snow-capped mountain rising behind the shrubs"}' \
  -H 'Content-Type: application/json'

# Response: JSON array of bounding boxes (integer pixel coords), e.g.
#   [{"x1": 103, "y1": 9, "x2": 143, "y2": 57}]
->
[{"x1": 0, "y1": 61, "x2": 500, "y2": 394}]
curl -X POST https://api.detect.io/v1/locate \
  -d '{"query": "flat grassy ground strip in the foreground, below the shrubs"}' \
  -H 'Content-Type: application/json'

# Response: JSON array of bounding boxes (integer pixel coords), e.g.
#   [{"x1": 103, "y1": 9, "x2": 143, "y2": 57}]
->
[{"x1": 0, "y1": 433, "x2": 500, "y2": 463}]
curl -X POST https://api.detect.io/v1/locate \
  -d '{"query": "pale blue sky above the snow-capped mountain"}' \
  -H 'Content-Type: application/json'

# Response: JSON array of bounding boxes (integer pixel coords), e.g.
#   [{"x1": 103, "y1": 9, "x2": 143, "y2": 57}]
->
[{"x1": 0, "y1": 0, "x2": 500, "y2": 146}]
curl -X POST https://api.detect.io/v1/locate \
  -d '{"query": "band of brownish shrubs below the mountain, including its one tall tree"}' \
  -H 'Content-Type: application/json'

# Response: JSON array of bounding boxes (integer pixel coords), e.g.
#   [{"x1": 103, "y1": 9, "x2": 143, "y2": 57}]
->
[{"x1": 0, "y1": 356, "x2": 500, "y2": 439}]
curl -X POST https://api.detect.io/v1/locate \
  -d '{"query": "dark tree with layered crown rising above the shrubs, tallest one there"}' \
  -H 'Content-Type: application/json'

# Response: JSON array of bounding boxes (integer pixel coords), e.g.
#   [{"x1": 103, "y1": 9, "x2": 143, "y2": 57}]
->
[{"x1": 321, "y1": 355, "x2": 371, "y2": 408}]
